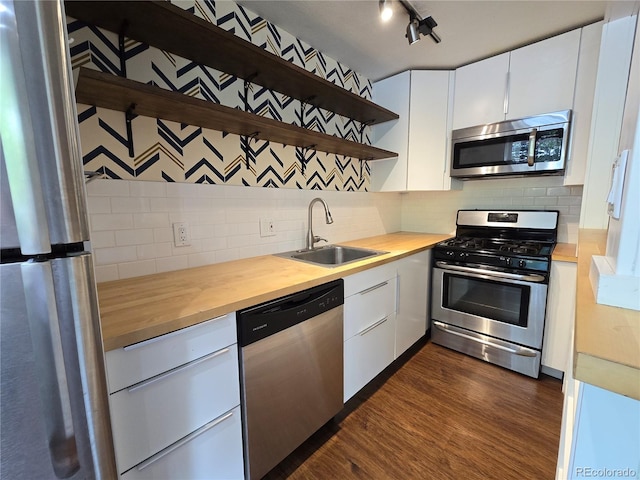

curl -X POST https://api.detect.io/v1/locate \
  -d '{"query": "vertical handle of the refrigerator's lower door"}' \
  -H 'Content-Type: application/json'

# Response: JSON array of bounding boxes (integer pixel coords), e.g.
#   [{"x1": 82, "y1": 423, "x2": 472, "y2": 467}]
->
[{"x1": 21, "y1": 262, "x2": 80, "y2": 479}]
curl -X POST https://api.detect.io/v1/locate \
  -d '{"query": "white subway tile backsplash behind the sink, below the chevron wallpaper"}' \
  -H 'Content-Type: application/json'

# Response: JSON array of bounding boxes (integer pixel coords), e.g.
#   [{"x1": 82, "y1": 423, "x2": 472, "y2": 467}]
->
[{"x1": 87, "y1": 180, "x2": 401, "y2": 282}]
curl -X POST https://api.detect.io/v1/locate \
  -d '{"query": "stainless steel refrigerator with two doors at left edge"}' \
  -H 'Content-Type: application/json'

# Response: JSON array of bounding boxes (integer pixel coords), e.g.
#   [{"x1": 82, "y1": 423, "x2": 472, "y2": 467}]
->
[{"x1": 0, "y1": 0, "x2": 117, "y2": 480}]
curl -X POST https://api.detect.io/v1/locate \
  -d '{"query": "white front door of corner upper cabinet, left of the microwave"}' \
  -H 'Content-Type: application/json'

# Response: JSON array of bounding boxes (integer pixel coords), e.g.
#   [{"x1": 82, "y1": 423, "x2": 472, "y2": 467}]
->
[{"x1": 407, "y1": 70, "x2": 452, "y2": 191}]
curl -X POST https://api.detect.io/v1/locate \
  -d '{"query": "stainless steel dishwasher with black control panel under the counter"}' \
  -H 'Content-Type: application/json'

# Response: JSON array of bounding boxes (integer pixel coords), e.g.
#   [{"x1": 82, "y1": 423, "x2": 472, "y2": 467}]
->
[{"x1": 237, "y1": 280, "x2": 344, "y2": 479}]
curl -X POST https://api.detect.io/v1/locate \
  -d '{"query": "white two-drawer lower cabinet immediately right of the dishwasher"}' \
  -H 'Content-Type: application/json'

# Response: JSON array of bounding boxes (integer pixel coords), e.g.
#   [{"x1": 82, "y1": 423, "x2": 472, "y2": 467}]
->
[{"x1": 344, "y1": 262, "x2": 396, "y2": 402}]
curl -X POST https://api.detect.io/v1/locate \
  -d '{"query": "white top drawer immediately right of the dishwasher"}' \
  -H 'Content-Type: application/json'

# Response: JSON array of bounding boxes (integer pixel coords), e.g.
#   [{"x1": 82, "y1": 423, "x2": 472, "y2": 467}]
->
[{"x1": 344, "y1": 276, "x2": 397, "y2": 340}]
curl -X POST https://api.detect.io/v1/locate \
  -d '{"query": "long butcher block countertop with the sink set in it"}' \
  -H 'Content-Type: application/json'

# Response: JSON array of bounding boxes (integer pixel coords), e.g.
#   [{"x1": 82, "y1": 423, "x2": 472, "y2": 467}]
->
[{"x1": 98, "y1": 232, "x2": 451, "y2": 351}]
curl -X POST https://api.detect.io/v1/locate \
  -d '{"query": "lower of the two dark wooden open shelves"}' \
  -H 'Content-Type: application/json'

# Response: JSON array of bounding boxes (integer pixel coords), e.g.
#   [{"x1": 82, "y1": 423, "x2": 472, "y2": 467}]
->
[{"x1": 76, "y1": 68, "x2": 398, "y2": 160}]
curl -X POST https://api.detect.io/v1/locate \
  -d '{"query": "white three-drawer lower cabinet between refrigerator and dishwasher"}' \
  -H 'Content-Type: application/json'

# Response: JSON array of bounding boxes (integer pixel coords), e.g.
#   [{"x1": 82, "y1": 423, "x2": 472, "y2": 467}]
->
[{"x1": 106, "y1": 313, "x2": 244, "y2": 480}]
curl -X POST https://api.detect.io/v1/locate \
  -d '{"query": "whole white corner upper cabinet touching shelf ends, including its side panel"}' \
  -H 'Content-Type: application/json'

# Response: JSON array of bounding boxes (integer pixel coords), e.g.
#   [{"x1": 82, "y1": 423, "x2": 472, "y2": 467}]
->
[{"x1": 370, "y1": 70, "x2": 453, "y2": 192}]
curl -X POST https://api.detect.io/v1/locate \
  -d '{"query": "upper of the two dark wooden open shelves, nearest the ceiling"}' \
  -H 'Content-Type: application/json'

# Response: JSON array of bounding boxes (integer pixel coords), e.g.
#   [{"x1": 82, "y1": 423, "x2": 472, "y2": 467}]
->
[{"x1": 65, "y1": 1, "x2": 398, "y2": 125}]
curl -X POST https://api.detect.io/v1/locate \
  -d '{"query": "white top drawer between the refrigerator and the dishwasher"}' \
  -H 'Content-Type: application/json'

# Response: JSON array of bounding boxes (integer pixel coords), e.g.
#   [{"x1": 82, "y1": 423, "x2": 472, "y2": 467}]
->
[{"x1": 106, "y1": 312, "x2": 238, "y2": 393}]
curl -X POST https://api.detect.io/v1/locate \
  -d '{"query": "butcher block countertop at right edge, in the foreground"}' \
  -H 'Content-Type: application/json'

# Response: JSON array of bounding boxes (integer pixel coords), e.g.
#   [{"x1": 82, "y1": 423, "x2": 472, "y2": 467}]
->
[{"x1": 573, "y1": 230, "x2": 640, "y2": 400}]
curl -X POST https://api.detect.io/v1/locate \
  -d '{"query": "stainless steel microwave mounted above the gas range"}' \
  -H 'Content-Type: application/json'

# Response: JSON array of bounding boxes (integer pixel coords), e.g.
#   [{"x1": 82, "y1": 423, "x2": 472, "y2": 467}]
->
[{"x1": 451, "y1": 110, "x2": 571, "y2": 178}]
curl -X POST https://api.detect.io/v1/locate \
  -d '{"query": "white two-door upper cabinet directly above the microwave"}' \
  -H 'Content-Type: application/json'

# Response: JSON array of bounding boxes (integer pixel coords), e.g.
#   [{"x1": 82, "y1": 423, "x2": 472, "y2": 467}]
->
[{"x1": 453, "y1": 29, "x2": 581, "y2": 130}]
